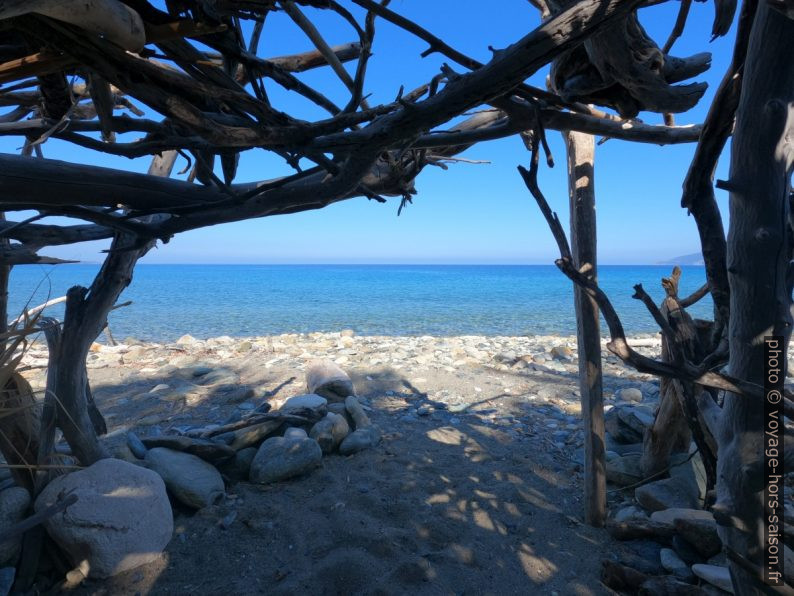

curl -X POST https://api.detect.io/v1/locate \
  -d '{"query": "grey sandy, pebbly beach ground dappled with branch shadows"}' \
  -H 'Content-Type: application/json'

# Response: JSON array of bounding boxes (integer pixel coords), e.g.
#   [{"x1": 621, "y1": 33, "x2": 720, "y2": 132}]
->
[{"x1": 17, "y1": 334, "x2": 657, "y2": 595}]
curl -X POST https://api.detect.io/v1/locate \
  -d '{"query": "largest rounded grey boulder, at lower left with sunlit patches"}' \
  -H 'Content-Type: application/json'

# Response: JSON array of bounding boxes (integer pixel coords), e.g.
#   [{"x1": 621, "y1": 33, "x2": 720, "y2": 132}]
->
[{"x1": 35, "y1": 459, "x2": 174, "y2": 578}]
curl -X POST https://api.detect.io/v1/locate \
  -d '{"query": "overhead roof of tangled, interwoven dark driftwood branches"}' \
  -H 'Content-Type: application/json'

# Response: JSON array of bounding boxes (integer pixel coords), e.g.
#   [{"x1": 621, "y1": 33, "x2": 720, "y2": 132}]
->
[{"x1": 0, "y1": 0, "x2": 720, "y2": 263}]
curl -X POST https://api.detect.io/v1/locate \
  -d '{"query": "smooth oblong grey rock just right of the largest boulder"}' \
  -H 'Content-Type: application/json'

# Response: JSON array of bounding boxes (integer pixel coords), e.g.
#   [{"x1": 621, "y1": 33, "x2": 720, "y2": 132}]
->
[{"x1": 144, "y1": 447, "x2": 225, "y2": 509}]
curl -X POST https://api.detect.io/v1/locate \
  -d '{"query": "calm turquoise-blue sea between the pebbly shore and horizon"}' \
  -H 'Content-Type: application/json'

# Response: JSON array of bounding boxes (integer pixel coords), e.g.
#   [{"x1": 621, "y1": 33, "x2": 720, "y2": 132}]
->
[{"x1": 9, "y1": 264, "x2": 712, "y2": 341}]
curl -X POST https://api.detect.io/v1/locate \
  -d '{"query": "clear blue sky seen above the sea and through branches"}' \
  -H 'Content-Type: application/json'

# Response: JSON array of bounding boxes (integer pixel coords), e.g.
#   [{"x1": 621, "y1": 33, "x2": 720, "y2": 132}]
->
[{"x1": 0, "y1": 0, "x2": 735, "y2": 264}]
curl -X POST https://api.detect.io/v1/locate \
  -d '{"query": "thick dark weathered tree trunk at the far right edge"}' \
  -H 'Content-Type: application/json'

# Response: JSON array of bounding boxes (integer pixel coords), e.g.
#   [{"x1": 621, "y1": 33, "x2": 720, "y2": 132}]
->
[{"x1": 715, "y1": 2, "x2": 794, "y2": 594}]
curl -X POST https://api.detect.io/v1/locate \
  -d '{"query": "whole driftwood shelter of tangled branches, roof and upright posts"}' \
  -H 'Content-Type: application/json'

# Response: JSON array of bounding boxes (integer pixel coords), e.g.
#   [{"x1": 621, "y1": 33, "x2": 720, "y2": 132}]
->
[{"x1": 0, "y1": 0, "x2": 794, "y2": 593}]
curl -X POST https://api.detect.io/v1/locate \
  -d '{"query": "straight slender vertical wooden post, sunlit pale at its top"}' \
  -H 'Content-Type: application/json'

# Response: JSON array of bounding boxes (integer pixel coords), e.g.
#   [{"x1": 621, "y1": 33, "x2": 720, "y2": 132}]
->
[{"x1": 563, "y1": 131, "x2": 607, "y2": 527}]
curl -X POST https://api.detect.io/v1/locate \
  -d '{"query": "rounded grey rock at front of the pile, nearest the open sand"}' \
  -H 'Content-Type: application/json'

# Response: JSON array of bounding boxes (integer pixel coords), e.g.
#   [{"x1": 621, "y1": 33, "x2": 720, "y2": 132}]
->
[{"x1": 249, "y1": 437, "x2": 323, "y2": 484}]
